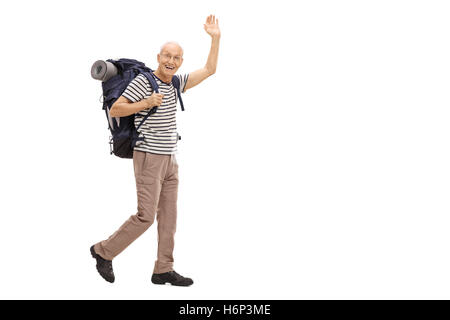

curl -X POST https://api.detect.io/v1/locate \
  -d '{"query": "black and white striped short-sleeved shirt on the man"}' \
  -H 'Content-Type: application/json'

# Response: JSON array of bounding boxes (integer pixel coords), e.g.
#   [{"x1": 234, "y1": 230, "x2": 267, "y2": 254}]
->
[{"x1": 122, "y1": 74, "x2": 189, "y2": 154}]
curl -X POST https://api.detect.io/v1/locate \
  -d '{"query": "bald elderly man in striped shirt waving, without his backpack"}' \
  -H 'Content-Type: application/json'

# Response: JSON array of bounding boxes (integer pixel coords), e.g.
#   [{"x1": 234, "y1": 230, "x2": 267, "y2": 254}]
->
[{"x1": 91, "y1": 15, "x2": 220, "y2": 286}]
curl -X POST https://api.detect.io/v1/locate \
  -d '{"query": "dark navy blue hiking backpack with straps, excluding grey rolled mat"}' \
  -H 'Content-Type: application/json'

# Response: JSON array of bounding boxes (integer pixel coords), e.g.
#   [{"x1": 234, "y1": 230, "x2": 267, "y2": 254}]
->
[{"x1": 102, "y1": 59, "x2": 184, "y2": 159}]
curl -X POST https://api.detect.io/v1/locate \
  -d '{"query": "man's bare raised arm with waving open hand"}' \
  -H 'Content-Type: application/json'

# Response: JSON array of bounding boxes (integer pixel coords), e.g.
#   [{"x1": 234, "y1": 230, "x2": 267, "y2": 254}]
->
[{"x1": 185, "y1": 15, "x2": 220, "y2": 90}]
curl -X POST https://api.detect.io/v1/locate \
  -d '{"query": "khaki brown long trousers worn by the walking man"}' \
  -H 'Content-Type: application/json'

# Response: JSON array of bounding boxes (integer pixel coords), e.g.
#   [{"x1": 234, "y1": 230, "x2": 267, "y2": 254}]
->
[{"x1": 94, "y1": 151, "x2": 178, "y2": 273}]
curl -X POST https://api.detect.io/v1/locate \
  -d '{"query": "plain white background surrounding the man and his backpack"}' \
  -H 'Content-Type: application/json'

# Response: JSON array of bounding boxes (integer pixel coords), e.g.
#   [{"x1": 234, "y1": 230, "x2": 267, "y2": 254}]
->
[{"x1": 0, "y1": 0, "x2": 450, "y2": 299}]
